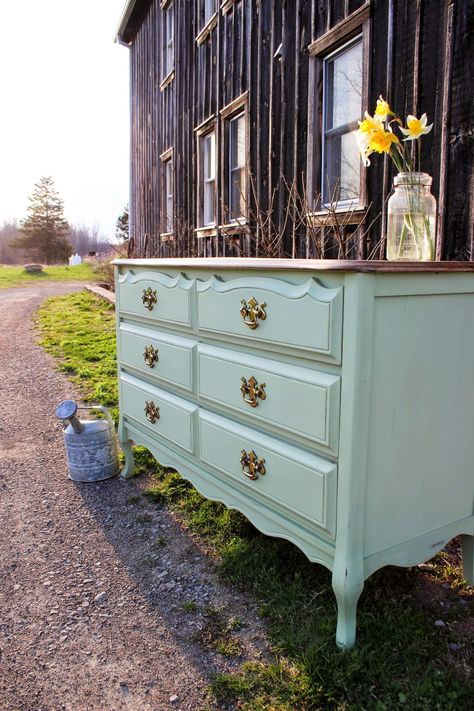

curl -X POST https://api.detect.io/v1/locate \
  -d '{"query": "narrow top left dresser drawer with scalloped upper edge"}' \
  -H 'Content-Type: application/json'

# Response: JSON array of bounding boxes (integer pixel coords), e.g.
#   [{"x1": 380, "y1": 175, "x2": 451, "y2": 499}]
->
[{"x1": 116, "y1": 269, "x2": 195, "y2": 328}]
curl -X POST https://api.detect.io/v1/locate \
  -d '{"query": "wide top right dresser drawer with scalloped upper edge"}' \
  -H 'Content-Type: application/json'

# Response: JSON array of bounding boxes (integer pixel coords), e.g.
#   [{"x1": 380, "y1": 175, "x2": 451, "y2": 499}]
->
[{"x1": 197, "y1": 277, "x2": 342, "y2": 363}]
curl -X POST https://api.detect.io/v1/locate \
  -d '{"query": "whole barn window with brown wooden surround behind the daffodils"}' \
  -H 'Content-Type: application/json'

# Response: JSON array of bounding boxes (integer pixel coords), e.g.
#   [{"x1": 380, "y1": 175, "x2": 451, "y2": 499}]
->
[{"x1": 306, "y1": 0, "x2": 372, "y2": 220}]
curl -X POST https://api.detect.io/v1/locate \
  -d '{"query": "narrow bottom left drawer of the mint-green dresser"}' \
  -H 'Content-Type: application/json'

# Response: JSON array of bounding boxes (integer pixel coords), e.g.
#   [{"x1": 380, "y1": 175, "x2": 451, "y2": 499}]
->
[{"x1": 120, "y1": 374, "x2": 198, "y2": 453}]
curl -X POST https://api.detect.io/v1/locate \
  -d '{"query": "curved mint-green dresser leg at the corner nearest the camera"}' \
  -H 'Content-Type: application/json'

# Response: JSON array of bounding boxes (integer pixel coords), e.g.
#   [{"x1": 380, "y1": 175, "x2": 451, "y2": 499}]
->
[{"x1": 332, "y1": 565, "x2": 364, "y2": 649}]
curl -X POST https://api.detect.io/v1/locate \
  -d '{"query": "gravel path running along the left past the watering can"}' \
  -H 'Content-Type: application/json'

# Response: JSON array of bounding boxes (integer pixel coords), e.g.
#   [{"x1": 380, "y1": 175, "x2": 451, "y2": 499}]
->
[{"x1": 0, "y1": 283, "x2": 267, "y2": 711}]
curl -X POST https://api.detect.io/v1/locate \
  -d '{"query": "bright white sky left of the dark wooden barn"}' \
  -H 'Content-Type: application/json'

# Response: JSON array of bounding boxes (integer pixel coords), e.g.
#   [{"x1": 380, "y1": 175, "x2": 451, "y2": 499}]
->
[{"x1": 0, "y1": 0, "x2": 129, "y2": 238}]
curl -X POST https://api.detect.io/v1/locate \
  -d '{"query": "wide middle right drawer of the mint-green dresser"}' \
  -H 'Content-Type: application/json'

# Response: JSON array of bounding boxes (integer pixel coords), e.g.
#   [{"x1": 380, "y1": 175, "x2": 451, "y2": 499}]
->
[{"x1": 198, "y1": 345, "x2": 340, "y2": 455}]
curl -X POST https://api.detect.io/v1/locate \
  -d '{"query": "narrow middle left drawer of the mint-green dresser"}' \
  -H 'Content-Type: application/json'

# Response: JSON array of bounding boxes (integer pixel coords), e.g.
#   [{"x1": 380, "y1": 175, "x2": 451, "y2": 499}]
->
[{"x1": 119, "y1": 323, "x2": 196, "y2": 391}]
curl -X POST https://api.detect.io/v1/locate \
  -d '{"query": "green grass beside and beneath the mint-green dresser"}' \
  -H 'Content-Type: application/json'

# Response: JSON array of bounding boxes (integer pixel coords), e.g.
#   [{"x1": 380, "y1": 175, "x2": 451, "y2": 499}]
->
[{"x1": 39, "y1": 294, "x2": 474, "y2": 711}]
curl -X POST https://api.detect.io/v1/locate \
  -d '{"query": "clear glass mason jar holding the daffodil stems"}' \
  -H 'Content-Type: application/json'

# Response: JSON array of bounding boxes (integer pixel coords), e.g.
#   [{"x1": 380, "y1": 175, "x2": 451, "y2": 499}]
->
[{"x1": 387, "y1": 173, "x2": 436, "y2": 261}]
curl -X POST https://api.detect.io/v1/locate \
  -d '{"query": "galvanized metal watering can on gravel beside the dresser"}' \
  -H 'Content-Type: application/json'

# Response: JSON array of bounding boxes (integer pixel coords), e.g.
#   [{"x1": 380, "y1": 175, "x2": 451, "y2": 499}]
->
[{"x1": 56, "y1": 400, "x2": 119, "y2": 482}]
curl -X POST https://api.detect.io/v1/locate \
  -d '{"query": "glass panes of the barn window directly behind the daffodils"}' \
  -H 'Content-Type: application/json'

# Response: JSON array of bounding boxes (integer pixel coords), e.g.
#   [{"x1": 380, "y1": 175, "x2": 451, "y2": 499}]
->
[{"x1": 321, "y1": 37, "x2": 362, "y2": 206}]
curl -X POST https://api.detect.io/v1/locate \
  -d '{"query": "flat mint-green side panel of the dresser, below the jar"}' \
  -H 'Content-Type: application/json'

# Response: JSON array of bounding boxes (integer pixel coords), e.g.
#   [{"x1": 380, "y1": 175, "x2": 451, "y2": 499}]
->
[{"x1": 365, "y1": 290, "x2": 474, "y2": 555}]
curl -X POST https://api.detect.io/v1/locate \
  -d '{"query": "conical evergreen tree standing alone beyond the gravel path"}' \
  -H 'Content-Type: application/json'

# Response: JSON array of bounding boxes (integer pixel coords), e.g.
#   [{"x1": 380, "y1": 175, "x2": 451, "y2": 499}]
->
[{"x1": 11, "y1": 177, "x2": 72, "y2": 264}]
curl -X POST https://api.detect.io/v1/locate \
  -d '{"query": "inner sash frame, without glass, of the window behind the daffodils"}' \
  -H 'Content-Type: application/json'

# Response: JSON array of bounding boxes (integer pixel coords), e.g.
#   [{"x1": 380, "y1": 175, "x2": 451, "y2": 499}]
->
[{"x1": 320, "y1": 33, "x2": 364, "y2": 210}]
